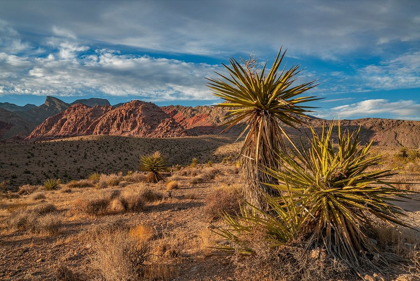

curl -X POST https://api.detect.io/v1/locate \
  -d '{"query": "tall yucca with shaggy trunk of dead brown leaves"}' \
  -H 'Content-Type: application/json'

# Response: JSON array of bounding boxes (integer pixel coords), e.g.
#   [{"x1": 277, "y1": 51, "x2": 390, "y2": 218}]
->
[{"x1": 208, "y1": 49, "x2": 316, "y2": 207}]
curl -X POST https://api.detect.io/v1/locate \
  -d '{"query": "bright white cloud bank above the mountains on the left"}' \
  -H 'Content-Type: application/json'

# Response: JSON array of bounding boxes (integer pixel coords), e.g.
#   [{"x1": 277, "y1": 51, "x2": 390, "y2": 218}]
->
[{"x1": 0, "y1": 38, "x2": 218, "y2": 101}]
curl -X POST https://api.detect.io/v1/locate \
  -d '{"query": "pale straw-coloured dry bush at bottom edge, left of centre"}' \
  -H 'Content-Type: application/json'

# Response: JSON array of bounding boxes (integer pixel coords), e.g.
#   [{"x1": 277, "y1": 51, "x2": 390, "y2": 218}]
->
[{"x1": 92, "y1": 230, "x2": 147, "y2": 281}]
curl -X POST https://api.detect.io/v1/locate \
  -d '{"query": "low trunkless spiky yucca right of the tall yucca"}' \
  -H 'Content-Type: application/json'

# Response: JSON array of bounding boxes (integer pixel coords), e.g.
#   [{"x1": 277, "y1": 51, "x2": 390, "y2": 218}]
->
[{"x1": 266, "y1": 124, "x2": 414, "y2": 268}]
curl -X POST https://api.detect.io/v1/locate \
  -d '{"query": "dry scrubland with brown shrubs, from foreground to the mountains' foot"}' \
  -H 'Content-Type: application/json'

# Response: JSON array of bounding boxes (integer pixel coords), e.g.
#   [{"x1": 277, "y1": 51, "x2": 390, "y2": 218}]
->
[{"x1": 0, "y1": 137, "x2": 420, "y2": 280}]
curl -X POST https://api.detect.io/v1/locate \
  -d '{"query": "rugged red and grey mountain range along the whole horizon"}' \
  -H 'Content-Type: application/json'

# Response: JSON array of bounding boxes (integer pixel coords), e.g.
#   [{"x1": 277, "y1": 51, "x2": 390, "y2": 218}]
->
[{"x1": 0, "y1": 97, "x2": 420, "y2": 148}]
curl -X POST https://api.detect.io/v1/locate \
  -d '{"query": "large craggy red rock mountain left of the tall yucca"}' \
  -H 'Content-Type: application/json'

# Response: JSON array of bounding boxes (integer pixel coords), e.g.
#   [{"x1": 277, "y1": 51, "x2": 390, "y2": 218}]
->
[{"x1": 26, "y1": 101, "x2": 187, "y2": 140}]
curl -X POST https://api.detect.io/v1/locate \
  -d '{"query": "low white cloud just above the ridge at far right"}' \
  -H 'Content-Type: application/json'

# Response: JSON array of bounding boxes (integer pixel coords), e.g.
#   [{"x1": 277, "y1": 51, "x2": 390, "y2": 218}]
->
[{"x1": 316, "y1": 99, "x2": 420, "y2": 120}]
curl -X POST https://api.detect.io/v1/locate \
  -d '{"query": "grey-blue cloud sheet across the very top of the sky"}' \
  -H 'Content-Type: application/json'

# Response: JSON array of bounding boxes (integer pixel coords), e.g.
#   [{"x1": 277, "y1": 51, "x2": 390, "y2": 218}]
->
[{"x1": 0, "y1": 0, "x2": 420, "y2": 59}]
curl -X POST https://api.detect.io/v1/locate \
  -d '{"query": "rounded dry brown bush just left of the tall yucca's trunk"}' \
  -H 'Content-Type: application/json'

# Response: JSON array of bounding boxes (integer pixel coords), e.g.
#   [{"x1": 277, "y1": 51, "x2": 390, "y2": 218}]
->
[{"x1": 205, "y1": 185, "x2": 242, "y2": 219}]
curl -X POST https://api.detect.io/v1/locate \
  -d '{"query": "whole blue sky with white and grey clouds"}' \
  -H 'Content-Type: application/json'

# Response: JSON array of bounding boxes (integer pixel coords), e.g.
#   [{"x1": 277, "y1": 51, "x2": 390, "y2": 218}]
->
[{"x1": 0, "y1": 0, "x2": 420, "y2": 120}]
